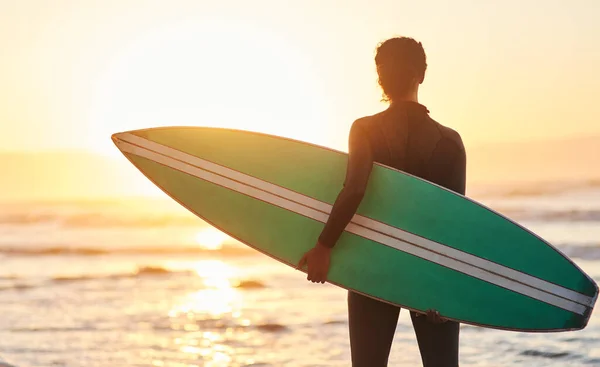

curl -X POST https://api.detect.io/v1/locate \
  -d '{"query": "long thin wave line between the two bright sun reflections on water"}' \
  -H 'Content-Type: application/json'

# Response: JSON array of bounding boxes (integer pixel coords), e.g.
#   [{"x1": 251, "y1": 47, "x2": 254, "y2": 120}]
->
[{"x1": 0, "y1": 246, "x2": 255, "y2": 256}]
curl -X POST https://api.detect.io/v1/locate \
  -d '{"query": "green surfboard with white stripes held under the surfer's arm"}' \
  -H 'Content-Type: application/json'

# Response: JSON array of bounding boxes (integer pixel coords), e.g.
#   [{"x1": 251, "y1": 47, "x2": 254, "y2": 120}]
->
[{"x1": 112, "y1": 127, "x2": 598, "y2": 332}]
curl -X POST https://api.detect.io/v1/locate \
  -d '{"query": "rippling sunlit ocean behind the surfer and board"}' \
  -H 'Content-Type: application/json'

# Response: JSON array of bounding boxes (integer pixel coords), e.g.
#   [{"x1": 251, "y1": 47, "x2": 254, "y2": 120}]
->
[{"x1": 0, "y1": 182, "x2": 600, "y2": 367}]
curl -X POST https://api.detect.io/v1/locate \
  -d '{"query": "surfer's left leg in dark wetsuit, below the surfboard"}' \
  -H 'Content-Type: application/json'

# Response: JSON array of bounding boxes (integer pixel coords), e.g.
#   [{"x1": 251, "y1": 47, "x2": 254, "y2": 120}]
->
[{"x1": 348, "y1": 291, "x2": 400, "y2": 367}]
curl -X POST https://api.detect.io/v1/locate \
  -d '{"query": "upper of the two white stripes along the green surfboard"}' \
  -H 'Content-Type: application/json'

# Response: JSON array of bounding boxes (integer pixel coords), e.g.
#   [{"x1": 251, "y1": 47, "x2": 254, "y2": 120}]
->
[{"x1": 118, "y1": 133, "x2": 594, "y2": 306}]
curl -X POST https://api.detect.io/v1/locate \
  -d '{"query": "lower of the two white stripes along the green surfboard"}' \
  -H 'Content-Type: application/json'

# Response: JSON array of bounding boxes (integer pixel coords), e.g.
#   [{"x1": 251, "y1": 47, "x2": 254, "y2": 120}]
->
[{"x1": 116, "y1": 141, "x2": 586, "y2": 315}]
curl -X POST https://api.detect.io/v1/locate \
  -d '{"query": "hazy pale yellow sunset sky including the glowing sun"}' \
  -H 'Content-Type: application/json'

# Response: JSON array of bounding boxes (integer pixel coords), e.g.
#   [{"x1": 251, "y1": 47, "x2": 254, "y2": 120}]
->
[{"x1": 0, "y1": 0, "x2": 600, "y2": 154}]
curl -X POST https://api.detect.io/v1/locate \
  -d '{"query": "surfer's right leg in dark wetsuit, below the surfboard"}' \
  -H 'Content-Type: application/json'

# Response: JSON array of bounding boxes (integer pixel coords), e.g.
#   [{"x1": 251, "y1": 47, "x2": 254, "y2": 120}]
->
[{"x1": 410, "y1": 312, "x2": 460, "y2": 367}]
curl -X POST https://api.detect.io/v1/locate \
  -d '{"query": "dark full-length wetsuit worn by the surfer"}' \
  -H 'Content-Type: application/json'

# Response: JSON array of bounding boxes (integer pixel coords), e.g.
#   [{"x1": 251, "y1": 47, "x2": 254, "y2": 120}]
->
[{"x1": 319, "y1": 102, "x2": 466, "y2": 367}]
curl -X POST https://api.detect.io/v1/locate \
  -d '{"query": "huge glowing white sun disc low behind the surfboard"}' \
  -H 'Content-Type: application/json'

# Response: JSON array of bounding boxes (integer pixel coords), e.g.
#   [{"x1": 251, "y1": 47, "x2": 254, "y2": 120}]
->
[{"x1": 87, "y1": 19, "x2": 329, "y2": 155}]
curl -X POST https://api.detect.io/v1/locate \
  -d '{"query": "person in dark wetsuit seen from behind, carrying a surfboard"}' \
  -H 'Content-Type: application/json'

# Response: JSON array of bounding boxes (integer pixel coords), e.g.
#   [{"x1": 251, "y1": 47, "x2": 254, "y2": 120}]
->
[{"x1": 298, "y1": 37, "x2": 466, "y2": 367}]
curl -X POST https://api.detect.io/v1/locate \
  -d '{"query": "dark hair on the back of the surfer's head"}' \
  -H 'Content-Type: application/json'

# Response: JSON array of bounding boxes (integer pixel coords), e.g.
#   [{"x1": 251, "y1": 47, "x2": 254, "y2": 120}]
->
[{"x1": 375, "y1": 37, "x2": 427, "y2": 102}]
